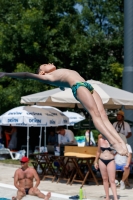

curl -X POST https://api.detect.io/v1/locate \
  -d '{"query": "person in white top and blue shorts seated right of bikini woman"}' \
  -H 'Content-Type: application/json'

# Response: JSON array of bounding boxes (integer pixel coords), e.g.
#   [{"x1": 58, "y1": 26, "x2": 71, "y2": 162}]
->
[{"x1": 115, "y1": 133, "x2": 132, "y2": 190}]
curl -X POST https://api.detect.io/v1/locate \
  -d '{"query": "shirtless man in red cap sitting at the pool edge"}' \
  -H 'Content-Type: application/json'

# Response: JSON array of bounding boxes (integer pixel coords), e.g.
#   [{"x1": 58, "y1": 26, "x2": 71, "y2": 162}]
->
[{"x1": 12, "y1": 157, "x2": 51, "y2": 200}]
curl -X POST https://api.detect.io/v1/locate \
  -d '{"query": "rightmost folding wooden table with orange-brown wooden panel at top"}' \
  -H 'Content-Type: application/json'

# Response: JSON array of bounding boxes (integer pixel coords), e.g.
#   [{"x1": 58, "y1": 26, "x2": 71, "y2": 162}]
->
[{"x1": 65, "y1": 146, "x2": 99, "y2": 186}]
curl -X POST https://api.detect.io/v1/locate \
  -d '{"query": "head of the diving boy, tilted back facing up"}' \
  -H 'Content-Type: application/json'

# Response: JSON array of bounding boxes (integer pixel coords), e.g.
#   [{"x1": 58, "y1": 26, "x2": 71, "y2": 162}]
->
[{"x1": 36, "y1": 63, "x2": 56, "y2": 75}]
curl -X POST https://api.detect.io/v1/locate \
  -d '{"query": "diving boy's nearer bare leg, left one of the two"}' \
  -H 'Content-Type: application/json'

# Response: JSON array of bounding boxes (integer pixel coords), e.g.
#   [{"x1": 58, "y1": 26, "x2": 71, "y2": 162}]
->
[{"x1": 77, "y1": 87, "x2": 127, "y2": 155}]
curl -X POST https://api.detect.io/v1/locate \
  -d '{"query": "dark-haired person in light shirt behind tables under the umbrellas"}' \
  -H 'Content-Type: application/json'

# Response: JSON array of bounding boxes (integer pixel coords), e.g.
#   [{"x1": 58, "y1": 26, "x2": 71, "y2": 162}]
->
[{"x1": 56, "y1": 126, "x2": 77, "y2": 145}]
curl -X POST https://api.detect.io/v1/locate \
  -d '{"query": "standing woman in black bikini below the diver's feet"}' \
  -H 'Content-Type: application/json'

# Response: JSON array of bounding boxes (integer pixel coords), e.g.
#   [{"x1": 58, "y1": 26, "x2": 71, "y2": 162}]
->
[{"x1": 94, "y1": 135, "x2": 118, "y2": 200}]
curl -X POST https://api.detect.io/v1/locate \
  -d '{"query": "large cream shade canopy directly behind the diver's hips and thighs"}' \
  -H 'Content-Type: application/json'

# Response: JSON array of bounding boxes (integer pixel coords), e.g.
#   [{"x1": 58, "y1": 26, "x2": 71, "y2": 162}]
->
[{"x1": 21, "y1": 80, "x2": 133, "y2": 109}]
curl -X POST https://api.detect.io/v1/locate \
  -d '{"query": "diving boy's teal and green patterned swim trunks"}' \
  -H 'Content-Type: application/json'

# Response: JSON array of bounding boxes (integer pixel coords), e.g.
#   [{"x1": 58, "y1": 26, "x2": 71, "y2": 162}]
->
[{"x1": 71, "y1": 82, "x2": 94, "y2": 100}]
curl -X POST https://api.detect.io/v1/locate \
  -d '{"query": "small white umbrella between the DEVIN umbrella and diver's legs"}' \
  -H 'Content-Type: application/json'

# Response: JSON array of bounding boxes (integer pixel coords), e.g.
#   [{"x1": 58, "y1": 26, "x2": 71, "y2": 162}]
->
[{"x1": 63, "y1": 110, "x2": 85, "y2": 126}]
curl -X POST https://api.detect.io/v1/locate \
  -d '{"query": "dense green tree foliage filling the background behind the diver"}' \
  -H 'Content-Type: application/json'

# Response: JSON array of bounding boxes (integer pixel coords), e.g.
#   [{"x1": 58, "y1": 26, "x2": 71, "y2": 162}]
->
[{"x1": 0, "y1": 0, "x2": 123, "y2": 114}]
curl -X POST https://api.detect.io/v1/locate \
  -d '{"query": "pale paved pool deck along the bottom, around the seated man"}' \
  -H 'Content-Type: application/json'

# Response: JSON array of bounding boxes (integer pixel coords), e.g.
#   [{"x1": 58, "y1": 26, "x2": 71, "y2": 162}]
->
[{"x1": 0, "y1": 163, "x2": 133, "y2": 200}]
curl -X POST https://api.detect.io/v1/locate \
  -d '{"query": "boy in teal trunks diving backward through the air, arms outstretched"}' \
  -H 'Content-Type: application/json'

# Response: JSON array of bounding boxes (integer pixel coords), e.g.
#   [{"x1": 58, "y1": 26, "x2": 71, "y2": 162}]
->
[{"x1": 0, "y1": 64, "x2": 128, "y2": 155}]
